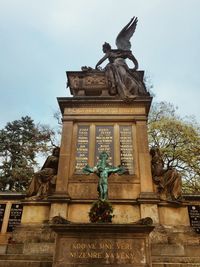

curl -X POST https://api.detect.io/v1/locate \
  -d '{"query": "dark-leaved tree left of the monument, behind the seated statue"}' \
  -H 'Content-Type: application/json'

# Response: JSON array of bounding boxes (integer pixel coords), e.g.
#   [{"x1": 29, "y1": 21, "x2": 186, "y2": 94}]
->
[{"x1": 0, "y1": 116, "x2": 54, "y2": 191}]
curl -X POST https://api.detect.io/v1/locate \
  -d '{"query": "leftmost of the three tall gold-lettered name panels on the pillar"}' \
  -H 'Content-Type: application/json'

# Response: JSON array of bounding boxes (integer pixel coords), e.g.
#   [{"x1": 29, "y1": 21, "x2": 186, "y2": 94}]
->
[{"x1": 75, "y1": 125, "x2": 90, "y2": 174}]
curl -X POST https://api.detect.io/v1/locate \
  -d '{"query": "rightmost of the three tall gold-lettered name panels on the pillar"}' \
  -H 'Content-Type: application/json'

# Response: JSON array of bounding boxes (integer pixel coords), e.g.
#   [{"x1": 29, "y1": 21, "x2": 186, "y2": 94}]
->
[{"x1": 119, "y1": 125, "x2": 134, "y2": 174}]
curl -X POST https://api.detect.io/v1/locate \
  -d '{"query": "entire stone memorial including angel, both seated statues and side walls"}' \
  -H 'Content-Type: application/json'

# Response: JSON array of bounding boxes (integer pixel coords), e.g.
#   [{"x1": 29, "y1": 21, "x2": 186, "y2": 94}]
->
[{"x1": 0, "y1": 17, "x2": 200, "y2": 267}]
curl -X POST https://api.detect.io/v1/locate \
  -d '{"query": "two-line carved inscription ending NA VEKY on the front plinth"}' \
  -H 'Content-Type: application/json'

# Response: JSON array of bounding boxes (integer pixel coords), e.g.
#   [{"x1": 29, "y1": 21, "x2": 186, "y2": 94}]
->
[{"x1": 59, "y1": 239, "x2": 146, "y2": 265}]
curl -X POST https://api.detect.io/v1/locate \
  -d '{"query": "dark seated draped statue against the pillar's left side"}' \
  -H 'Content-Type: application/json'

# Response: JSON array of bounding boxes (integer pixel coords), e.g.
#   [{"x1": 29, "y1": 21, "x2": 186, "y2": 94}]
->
[{"x1": 27, "y1": 147, "x2": 60, "y2": 200}]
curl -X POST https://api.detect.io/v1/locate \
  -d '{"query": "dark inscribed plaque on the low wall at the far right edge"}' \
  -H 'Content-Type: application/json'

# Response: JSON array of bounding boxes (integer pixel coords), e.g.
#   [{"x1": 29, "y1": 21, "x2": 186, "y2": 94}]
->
[{"x1": 188, "y1": 205, "x2": 200, "y2": 234}]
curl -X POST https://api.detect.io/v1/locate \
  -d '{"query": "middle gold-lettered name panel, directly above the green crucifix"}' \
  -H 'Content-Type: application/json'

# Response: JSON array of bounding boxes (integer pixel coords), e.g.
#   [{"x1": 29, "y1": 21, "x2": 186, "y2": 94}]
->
[{"x1": 95, "y1": 125, "x2": 114, "y2": 165}]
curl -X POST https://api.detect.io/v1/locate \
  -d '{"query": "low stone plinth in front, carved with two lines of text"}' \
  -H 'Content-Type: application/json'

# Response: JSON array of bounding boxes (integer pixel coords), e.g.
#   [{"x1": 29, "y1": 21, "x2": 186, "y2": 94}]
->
[{"x1": 52, "y1": 224, "x2": 154, "y2": 267}]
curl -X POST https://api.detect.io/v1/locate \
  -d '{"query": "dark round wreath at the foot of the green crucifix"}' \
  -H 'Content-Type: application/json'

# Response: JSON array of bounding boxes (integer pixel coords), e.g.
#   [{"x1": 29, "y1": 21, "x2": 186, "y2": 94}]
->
[{"x1": 89, "y1": 199, "x2": 114, "y2": 223}]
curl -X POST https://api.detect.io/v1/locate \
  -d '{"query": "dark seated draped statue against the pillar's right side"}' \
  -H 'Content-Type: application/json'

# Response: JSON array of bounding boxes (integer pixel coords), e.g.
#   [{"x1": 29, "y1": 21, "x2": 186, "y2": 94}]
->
[{"x1": 150, "y1": 147, "x2": 182, "y2": 201}]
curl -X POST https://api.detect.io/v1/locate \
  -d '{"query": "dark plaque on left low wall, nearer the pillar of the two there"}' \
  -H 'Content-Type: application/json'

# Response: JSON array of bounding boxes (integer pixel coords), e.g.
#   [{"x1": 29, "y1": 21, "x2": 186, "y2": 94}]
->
[{"x1": 7, "y1": 204, "x2": 23, "y2": 232}]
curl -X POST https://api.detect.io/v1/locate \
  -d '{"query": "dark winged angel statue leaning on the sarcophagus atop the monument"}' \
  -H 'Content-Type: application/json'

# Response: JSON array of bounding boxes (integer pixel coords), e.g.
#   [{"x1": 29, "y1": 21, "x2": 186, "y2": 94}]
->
[{"x1": 95, "y1": 17, "x2": 147, "y2": 100}]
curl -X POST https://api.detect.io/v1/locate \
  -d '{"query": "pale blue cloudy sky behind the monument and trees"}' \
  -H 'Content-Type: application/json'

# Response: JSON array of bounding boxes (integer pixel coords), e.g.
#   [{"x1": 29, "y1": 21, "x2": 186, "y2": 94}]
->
[{"x1": 0, "y1": 0, "x2": 200, "y2": 128}]
